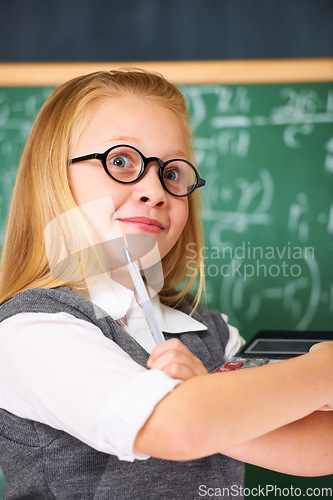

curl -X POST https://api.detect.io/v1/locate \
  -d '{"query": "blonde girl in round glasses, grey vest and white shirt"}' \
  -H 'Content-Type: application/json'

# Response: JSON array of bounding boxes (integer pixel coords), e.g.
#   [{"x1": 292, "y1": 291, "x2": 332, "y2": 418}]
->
[{"x1": 0, "y1": 70, "x2": 333, "y2": 500}]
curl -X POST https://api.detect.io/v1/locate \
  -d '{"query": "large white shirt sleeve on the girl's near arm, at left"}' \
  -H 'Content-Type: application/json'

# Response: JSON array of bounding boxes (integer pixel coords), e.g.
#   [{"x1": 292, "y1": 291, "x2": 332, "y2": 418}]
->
[{"x1": 0, "y1": 313, "x2": 180, "y2": 461}]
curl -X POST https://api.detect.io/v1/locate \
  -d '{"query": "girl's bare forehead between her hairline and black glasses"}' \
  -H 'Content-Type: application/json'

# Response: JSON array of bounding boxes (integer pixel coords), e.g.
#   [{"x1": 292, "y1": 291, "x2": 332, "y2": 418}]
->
[{"x1": 75, "y1": 96, "x2": 189, "y2": 154}]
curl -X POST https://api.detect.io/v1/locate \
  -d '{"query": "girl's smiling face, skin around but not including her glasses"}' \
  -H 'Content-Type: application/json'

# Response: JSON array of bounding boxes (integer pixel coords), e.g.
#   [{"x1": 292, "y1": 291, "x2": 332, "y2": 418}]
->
[{"x1": 69, "y1": 96, "x2": 190, "y2": 258}]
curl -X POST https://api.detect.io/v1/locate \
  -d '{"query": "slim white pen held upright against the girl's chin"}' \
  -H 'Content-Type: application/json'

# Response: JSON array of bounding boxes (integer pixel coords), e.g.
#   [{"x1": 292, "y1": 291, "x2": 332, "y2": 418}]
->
[{"x1": 124, "y1": 245, "x2": 165, "y2": 344}]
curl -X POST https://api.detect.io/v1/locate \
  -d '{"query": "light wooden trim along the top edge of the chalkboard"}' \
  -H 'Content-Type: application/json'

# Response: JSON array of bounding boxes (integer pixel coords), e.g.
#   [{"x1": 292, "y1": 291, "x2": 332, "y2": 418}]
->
[{"x1": 0, "y1": 58, "x2": 333, "y2": 87}]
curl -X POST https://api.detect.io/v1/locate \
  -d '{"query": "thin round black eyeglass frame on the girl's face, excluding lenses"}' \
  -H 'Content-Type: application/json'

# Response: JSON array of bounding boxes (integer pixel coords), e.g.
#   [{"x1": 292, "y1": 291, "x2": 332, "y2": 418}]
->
[{"x1": 68, "y1": 144, "x2": 206, "y2": 198}]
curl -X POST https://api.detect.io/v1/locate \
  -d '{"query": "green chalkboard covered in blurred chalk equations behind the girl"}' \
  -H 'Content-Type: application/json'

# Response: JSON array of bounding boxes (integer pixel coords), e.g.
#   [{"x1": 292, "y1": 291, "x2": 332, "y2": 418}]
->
[{"x1": 0, "y1": 83, "x2": 333, "y2": 498}]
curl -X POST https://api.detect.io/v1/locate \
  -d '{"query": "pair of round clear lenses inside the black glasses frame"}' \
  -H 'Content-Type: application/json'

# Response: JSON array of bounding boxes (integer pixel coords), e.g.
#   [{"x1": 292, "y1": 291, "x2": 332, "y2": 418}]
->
[{"x1": 106, "y1": 146, "x2": 196, "y2": 196}]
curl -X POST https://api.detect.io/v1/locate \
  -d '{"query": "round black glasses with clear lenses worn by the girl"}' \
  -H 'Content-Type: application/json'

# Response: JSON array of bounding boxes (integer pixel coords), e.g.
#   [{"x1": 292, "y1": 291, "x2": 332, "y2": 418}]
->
[{"x1": 68, "y1": 144, "x2": 206, "y2": 198}]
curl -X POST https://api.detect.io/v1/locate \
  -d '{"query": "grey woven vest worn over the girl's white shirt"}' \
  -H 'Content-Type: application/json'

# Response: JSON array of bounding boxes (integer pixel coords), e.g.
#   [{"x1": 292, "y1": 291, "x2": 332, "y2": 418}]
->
[{"x1": 0, "y1": 287, "x2": 244, "y2": 500}]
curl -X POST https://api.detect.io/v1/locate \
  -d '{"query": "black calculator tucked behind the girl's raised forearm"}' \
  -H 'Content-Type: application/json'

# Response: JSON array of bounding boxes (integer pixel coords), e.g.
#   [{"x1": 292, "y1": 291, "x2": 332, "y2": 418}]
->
[{"x1": 215, "y1": 330, "x2": 333, "y2": 372}]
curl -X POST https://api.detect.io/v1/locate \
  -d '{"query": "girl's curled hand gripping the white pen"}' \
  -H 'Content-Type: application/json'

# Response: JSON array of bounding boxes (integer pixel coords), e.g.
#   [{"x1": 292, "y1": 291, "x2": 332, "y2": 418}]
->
[{"x1": 147, "y1": 339, "x2": 208, "y2": 380}]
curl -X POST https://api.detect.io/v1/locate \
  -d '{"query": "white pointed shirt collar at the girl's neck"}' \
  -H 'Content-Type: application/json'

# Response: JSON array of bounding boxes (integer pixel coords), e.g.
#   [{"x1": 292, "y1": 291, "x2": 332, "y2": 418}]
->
[{"x1": 85, "y1": 275, "x2": 207, "y2": 334}]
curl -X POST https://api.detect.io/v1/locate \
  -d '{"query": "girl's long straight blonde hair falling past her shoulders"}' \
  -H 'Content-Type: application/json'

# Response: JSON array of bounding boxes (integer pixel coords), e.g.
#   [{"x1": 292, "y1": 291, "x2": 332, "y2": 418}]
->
[{"x1": 0, "y1": 68, "x2": 204, "y2": 305}]
